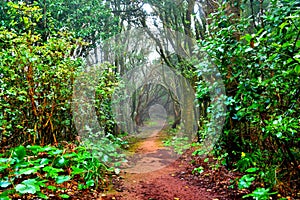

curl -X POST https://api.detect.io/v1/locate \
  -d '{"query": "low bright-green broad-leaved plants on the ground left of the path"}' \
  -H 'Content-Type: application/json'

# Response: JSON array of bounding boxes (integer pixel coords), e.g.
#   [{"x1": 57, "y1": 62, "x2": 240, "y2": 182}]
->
[{"x1": 0, "y1": 145, "x2": 113, "y2": 198}]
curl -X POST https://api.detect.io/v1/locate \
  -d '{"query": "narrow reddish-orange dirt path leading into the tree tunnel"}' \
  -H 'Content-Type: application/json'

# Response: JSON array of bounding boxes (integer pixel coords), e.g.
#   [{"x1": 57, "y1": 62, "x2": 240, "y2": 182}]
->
[{"x1": 105, "y1": 122, "x2": 218, "y2": 200}]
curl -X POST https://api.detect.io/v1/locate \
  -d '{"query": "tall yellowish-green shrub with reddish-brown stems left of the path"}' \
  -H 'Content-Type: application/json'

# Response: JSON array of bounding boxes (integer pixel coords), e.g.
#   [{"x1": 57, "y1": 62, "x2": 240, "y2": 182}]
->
[{"x1": 0, "y1": 3, "x2": 81, "y2": 144}]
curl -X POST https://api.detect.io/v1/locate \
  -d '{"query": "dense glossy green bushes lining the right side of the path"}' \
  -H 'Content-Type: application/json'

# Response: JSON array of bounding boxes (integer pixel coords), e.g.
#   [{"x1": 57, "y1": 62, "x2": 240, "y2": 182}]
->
[{"x1": 197, "y1": 0, "x2": 300, "y2": 198}]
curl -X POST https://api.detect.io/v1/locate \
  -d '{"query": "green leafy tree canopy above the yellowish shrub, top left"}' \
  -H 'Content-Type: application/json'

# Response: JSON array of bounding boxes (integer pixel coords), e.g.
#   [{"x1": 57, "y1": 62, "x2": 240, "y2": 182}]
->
[{"x1": 0, "y1": 0, "x2": 119, "y2": 47}]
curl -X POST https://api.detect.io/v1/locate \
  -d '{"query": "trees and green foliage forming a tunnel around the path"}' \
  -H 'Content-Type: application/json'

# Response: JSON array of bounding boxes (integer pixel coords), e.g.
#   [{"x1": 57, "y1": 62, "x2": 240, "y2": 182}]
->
[{"x1": 0, "y1": 0, "x2": 300, "y2": 199}]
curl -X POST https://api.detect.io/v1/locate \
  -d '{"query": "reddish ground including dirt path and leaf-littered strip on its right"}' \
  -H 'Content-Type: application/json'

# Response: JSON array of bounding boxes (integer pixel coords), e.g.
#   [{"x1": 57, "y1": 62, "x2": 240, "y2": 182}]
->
[{"x1": 100, "y1": 122, "x2": 246, "y2": 200}]
